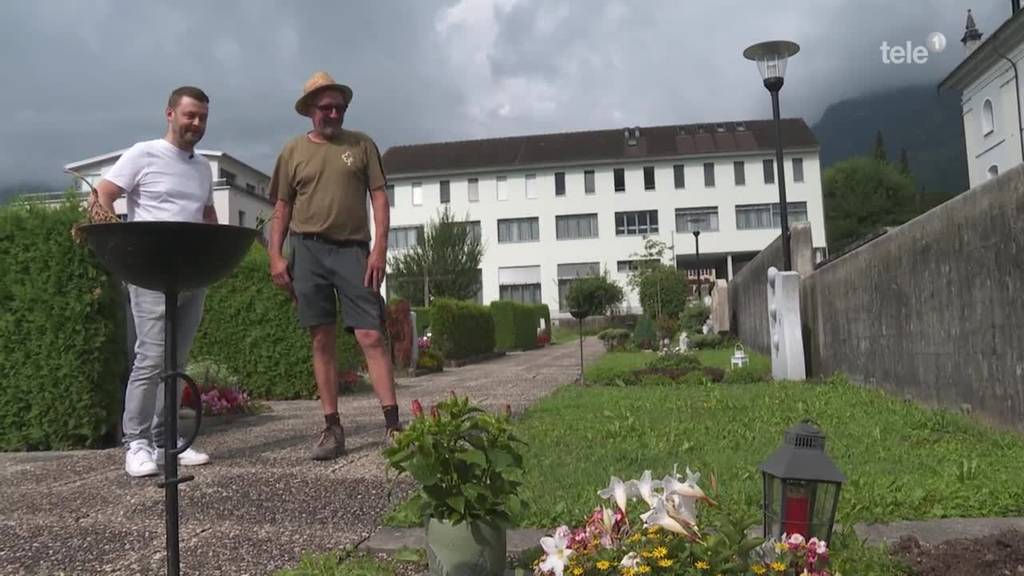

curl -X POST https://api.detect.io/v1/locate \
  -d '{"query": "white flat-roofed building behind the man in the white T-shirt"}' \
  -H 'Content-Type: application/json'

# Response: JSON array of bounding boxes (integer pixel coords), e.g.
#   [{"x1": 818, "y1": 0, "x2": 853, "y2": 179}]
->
[{"x1": 56, "y1": 149, "x2": 273, "y2": 239}]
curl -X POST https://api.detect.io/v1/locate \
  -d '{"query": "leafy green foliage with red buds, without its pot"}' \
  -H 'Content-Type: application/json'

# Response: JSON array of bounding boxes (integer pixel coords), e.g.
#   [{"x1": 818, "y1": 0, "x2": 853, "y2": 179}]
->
[{"x1": 384, "y1": 393, "x2": 523, "y2": 524}]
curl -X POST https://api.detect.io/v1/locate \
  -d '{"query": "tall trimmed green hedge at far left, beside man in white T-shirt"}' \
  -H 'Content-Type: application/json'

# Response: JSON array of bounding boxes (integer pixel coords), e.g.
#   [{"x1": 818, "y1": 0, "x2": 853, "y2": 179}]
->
[{"x1": 0, "y1": 200, "x2": 126, "y2": 450}]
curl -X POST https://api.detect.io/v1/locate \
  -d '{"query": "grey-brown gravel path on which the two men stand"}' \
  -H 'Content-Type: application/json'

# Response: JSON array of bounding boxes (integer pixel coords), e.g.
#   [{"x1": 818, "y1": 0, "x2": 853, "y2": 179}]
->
[{"x1": 0, "y1": 338, "x2": 601, "y2": 576}]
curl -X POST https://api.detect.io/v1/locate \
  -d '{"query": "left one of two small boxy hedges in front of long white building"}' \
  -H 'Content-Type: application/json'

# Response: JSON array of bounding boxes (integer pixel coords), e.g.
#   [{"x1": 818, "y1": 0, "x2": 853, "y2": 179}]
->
[{"x1": 430, "y1": 298, "x2": 495, "y2": 360}]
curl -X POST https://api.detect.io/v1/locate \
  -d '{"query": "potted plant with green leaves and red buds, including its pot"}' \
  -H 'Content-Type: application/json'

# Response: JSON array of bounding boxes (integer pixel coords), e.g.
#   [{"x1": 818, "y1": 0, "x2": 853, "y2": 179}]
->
[{"x1": 384, "y1": 393, "x2": 522, "y2": 576}]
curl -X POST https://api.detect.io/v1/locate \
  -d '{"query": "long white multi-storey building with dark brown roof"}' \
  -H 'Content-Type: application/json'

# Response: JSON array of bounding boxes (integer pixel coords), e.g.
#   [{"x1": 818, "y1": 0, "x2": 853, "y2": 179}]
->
[{"x1": 384, "y1": 119, "x2": 826, "y2": 318}]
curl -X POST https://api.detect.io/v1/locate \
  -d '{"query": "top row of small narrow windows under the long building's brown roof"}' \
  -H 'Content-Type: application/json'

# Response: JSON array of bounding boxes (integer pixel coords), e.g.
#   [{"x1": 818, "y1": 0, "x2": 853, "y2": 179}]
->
[{"x1": 387, "y1": 158, "x2": 804, "y2": 207}]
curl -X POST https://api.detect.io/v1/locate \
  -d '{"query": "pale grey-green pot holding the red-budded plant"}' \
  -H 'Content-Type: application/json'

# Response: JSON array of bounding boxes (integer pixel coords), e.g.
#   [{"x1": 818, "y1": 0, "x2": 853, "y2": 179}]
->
[{"x1": 427, "y1": 519, "x2": 506, "y2": 576}]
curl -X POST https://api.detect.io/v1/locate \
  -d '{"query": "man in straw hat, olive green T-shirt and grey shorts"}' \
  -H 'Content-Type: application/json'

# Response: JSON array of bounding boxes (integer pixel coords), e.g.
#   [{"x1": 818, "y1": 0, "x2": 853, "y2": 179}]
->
[{"x1": 269, "y1": 72, "x2": 401, "y2": 460}]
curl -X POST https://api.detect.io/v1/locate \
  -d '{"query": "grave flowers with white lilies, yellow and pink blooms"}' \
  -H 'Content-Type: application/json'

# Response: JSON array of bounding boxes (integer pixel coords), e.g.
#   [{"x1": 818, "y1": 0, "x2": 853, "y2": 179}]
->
[{"x1": 534, "y1": 468, "x2": 839, "y2": 576}]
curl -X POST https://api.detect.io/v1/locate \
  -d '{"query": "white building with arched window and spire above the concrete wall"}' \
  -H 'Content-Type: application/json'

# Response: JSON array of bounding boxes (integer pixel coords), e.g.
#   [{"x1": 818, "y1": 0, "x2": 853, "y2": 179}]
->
[{"x1": 939, "y1": 5, "x2": 1024, "y2": 188}]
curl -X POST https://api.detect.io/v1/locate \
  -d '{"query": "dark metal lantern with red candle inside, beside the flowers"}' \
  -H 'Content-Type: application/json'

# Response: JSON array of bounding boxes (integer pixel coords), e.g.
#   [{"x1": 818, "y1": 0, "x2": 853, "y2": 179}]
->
[{"x1": 759, "y1": 420, "x2": 846, "y2": 542}]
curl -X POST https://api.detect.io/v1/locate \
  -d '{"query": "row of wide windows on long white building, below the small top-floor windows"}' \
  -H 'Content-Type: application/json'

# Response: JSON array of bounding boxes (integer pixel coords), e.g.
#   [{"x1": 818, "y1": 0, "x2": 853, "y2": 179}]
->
[{"x1": 388, "y1": 202, "x2": 807, "y2": 250}]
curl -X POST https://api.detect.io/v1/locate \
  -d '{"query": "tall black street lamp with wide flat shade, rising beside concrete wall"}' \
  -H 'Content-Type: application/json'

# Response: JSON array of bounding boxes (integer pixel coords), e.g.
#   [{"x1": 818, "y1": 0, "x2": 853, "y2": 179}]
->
[{"x1": 743, "y1": 40, "x2": 800, "y2": 272}]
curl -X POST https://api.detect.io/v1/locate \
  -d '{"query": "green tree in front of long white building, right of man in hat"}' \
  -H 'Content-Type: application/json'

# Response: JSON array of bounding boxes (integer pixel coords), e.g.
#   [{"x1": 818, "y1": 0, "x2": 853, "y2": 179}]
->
[{"x1": 388, "y1": 206, "x2": 484, "y2": 305}]
